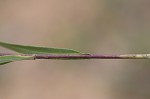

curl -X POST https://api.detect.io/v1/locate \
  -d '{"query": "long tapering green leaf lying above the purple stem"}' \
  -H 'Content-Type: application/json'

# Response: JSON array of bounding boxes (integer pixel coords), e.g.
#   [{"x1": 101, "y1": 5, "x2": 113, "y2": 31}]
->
[{"x1": 0, "y1": 42, "x2": 80, "y2": 54}]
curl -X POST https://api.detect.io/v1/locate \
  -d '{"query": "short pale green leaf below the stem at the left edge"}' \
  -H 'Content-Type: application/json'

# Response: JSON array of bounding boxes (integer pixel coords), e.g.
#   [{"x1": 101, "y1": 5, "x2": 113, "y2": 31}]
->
[{"x1": 0, "y1": 55, "x2": 34, "y2": 65}]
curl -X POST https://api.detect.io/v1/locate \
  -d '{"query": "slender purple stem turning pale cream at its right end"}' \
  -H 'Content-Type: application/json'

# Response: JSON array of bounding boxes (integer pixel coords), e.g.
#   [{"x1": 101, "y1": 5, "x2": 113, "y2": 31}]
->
[{"x1": 0, "y1": 53, "x2": 150, "y2": 59}]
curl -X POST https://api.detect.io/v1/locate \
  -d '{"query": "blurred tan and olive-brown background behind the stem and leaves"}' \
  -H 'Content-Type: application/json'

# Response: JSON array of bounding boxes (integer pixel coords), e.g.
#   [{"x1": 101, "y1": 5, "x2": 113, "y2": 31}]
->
[{"x1": 0, "y1": 0, "x2": 150, "y2": 99}]
